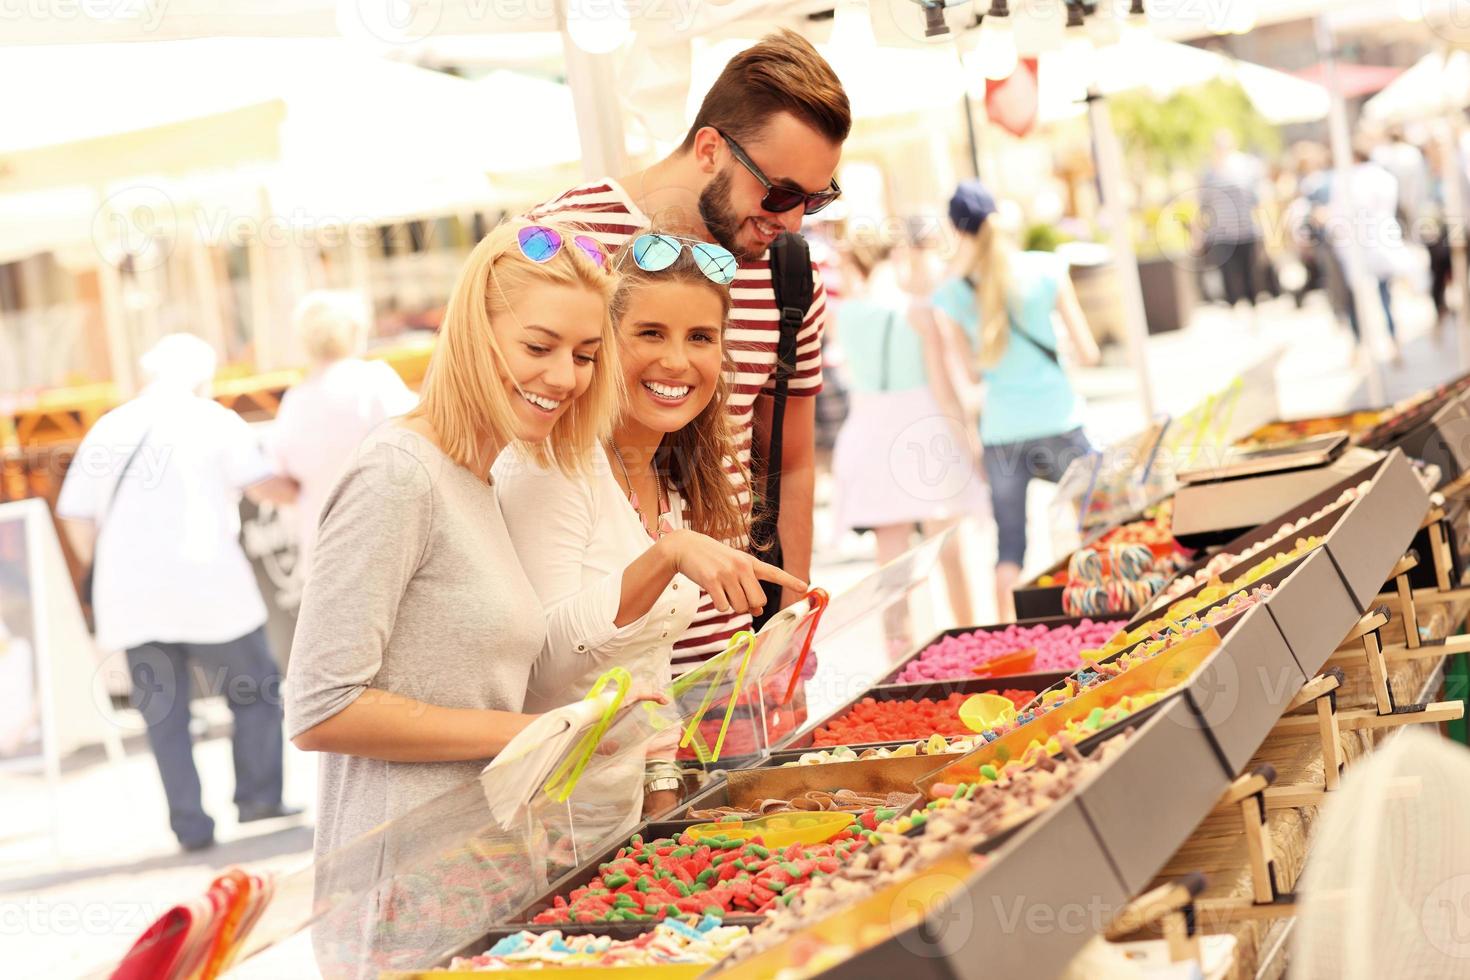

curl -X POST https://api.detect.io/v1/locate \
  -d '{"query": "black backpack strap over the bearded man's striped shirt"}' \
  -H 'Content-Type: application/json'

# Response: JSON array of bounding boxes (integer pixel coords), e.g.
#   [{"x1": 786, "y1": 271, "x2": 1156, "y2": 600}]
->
[{"x1": 751, "y1": 232, "x2": 814, "y2": 613}]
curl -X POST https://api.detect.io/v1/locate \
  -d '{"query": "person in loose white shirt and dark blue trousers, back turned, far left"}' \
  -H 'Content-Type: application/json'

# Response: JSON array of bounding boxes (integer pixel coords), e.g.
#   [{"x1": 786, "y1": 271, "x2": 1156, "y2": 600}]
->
[{"x1": 56, "y1": 334, "x2": 300, "y2": 851}]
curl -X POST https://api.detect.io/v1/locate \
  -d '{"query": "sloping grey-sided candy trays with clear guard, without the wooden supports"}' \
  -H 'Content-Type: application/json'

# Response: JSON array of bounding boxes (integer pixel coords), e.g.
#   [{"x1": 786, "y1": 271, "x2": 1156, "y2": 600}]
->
[{"x1": 106, "y1": 399, "x2": 1463, "y2": 980}]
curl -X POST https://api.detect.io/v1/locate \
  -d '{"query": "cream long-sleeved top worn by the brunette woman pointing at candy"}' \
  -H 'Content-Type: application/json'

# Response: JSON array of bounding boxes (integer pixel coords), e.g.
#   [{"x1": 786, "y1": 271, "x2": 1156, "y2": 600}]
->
[{"x1": 492, "y1": 450, "x2": 700, "y2": 711}]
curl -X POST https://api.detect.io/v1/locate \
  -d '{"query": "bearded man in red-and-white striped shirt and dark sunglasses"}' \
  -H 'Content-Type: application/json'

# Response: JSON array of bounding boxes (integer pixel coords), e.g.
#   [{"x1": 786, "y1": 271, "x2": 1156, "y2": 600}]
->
[{"x1": 529, "y1": 31, "x2": 851, "y2": 674}]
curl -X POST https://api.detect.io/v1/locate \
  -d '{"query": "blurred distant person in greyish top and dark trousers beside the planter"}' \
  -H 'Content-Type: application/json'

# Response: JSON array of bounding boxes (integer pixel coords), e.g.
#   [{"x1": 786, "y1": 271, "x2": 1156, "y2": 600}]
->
[{"x1": 1195, "y1": 129, "x2": 1266, "y2": 307}]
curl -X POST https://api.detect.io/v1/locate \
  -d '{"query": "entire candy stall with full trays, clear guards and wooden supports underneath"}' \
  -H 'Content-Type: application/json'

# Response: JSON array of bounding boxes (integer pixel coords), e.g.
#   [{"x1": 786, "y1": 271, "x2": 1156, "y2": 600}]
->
[{"x1": 106, "y1": 399, "x2": 1470, "y2": 980}]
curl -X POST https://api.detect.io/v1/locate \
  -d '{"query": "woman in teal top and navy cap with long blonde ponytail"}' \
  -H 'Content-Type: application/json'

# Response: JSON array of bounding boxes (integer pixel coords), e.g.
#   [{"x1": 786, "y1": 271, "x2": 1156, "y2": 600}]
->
[{"x1": 933, "y1": 181, "x2": 1098, "y2": 620}]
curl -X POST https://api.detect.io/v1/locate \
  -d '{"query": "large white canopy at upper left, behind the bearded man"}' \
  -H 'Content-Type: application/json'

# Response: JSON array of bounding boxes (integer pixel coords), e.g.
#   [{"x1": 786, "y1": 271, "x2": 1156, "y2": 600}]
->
[{"x1": 0, "y1": 40, "x2": 626, "y2": 260}]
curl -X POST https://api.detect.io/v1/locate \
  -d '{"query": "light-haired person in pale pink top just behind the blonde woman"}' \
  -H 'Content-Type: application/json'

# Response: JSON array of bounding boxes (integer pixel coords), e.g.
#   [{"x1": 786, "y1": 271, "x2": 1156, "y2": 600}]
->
[{"x1": 269, "y1": 289, "x2": 419, "y2": 583}]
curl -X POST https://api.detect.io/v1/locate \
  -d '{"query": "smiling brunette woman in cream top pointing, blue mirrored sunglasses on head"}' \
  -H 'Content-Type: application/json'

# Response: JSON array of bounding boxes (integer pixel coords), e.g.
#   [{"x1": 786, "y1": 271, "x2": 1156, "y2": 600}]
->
[{"x1": 494, "y1": 232, "x2": 807, "y2": 814}]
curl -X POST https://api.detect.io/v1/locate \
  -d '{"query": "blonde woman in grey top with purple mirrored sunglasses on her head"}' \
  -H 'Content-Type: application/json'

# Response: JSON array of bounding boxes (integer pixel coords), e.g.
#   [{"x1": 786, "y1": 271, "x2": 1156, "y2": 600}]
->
[{"x1": 287, "y1": 222, "x2": 632, "y2": 855}]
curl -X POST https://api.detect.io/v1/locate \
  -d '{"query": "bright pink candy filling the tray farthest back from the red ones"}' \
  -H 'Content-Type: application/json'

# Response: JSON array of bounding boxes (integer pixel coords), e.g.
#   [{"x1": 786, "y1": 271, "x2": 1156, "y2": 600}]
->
[{"x1": 895, "y1": 620, "x2": 1126, "y2": 683}]
